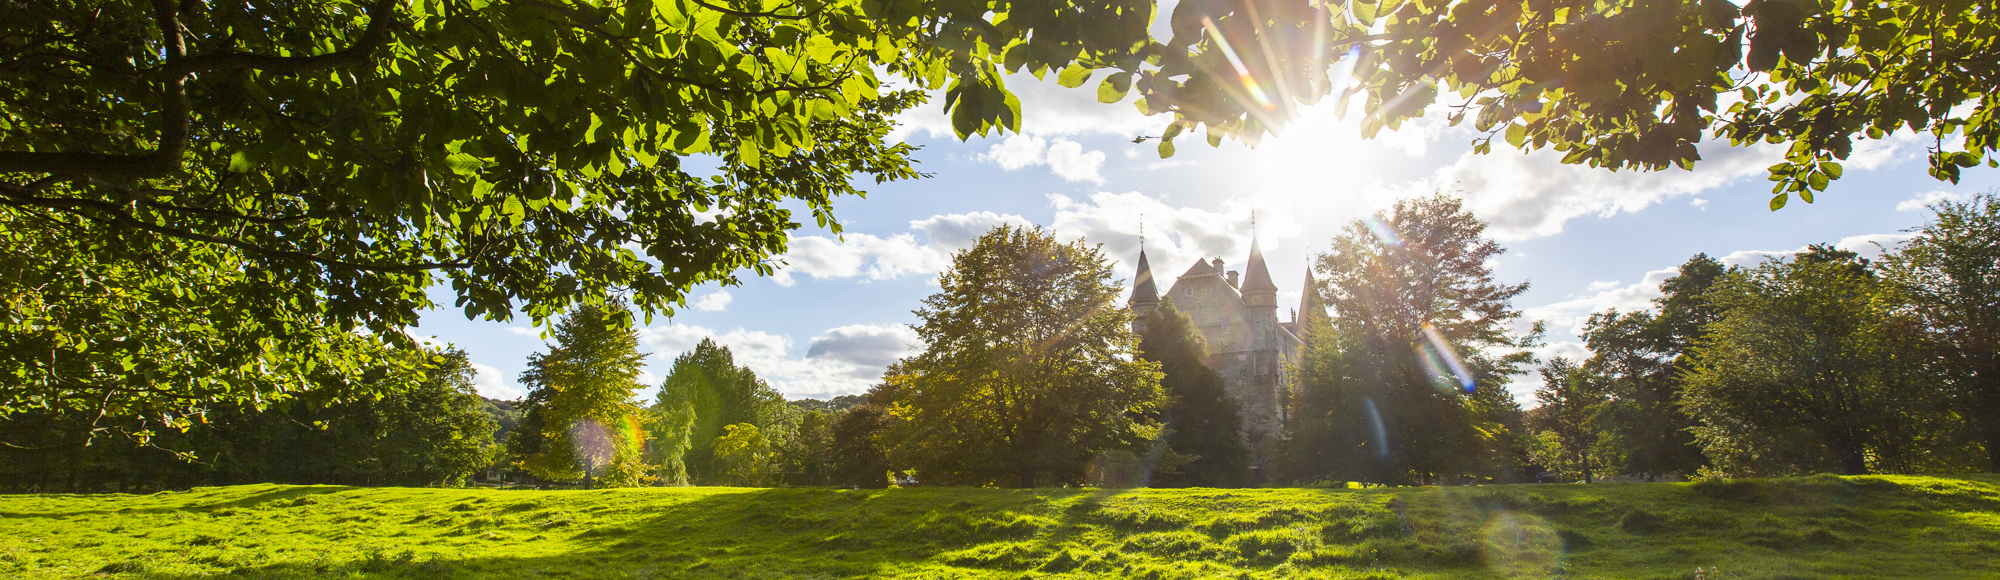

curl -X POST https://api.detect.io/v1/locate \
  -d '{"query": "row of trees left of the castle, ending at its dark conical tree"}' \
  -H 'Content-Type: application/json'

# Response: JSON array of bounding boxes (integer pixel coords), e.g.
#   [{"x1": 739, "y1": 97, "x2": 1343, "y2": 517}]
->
[{"x1": 496, "y1": 226, "x2": 1248, "y2": 486}]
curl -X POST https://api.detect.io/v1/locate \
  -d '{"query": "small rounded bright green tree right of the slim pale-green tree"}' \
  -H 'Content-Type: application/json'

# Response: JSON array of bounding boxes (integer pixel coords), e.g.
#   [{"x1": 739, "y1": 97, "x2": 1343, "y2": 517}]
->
[{"x1": 652, "y1": 338, "x2": 788, "y2": 486}]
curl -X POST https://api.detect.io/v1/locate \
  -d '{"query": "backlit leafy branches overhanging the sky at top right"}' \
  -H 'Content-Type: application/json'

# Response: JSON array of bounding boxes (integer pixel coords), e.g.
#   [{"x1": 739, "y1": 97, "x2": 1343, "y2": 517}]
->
[{"x1": 1104, "y1": 0, "x2": 2000, "y2": 210}]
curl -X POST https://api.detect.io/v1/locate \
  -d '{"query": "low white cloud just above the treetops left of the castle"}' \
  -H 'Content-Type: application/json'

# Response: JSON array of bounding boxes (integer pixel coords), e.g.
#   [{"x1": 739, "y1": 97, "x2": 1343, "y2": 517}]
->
[{"x1": 640, "y1": 324, "x2": 916, "y2": 398}]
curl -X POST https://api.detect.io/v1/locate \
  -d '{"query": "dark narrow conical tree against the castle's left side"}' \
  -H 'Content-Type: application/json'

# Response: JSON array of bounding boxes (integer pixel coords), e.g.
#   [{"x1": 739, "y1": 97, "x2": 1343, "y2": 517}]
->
[{"x1": 1138, "y1": 298, "x2": 1250, "y2": 488}]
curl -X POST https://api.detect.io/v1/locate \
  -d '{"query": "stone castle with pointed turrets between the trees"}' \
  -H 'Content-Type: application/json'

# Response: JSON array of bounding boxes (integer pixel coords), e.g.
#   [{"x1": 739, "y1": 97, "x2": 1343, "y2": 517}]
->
[{"x1": 1126, "y1": 238, "x2": 1326, "y2": 480}]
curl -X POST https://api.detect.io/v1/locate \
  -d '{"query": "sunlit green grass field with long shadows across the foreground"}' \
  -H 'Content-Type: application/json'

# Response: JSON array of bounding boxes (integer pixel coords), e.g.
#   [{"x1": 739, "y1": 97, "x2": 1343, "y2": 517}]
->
[{"x1": 0, "y1": 476, "x2": 2000, "y2": 580}]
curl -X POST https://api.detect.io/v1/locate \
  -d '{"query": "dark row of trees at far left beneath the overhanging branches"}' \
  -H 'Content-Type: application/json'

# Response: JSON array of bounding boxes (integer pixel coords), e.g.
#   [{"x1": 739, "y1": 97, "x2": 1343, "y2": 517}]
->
[{"x1": 0, "y1": 346, "x2": 508, "y2": 492}]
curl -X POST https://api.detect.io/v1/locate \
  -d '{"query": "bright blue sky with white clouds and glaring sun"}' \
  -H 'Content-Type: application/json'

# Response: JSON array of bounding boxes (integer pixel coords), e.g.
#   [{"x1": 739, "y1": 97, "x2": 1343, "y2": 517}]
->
[{"x1": 410, "y1": 74, "x2": 2000, "y2": 406}]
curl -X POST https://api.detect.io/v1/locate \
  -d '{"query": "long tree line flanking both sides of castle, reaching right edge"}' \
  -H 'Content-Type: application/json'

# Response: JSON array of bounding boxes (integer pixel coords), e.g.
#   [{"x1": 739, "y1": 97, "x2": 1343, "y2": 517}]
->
[{"x1": 514, "y1": 194, "x2": 2000, "y2": 486}]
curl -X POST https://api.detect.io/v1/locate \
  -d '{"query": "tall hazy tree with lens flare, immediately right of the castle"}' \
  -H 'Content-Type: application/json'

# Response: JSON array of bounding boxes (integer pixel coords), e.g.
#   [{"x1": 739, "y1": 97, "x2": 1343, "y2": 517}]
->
[{"x1": 1292, "y1": 194, "x2": 1540, "y2": 484}]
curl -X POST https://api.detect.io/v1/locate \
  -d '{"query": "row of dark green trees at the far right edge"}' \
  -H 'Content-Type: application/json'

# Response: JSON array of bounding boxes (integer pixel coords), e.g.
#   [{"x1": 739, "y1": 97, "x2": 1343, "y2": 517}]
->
[{"x1": 1534, "y1": 194, "x2": 2000, "y2": 480}]
